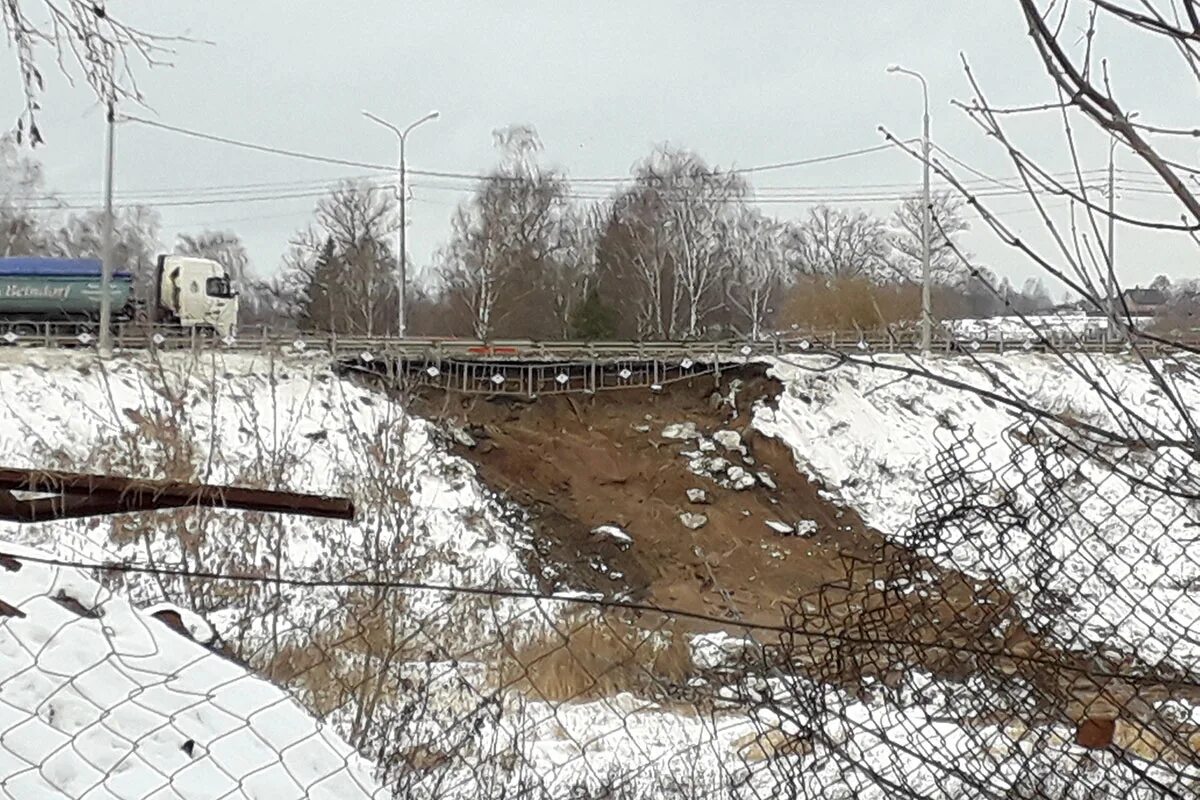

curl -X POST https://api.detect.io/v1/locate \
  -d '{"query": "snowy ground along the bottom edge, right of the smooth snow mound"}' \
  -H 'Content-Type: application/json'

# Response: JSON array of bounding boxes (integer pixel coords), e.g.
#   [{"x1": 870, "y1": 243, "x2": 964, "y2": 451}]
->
[{"x1": 393, "y1": 657, "x2": 1200, "y2": 800}]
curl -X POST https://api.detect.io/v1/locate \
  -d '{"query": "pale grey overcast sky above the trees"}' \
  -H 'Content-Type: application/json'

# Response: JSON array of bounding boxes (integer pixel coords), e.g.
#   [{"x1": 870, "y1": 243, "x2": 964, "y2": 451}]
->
[{"x1": 0, "y1": 0, "x2": 1198, "y2": 293}]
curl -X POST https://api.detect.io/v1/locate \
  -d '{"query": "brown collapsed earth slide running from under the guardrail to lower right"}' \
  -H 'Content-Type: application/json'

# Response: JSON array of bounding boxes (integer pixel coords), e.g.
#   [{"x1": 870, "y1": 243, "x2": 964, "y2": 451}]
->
[{"x1": 398, "y1": 367, "x2": 1200, "y2": 753}]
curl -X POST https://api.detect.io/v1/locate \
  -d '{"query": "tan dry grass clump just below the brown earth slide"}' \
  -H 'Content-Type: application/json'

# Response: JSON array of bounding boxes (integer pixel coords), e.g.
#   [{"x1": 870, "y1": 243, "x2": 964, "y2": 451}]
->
[{"x1": 502, "y1": 614, "x2": 692, "y2": 702}]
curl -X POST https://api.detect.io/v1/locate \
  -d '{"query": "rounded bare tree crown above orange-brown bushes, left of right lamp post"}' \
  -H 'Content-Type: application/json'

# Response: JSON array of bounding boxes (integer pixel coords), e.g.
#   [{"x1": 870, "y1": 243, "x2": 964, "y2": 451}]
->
[{"x1": 786, "y1": 205, "x2": 890, "y2": 279}]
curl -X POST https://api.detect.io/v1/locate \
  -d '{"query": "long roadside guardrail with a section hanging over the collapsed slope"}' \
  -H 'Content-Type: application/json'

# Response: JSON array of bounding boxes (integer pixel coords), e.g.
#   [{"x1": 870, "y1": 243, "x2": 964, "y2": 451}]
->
[{"x1": 0, "y1": 324, "x2": 1161, "y2": 396}]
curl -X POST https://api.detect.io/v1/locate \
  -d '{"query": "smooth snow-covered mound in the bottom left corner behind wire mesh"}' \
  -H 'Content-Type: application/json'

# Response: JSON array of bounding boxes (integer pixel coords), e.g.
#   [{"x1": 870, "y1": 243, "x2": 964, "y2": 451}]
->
[{"x1": 0, "y1": 541, "x2": 388, "y2": 800}]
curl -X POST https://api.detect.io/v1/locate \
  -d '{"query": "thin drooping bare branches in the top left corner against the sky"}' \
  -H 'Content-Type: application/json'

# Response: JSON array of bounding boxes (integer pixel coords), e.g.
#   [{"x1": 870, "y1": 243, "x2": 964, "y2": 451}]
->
[{"x1": 0, "y1": 0, "x2": 185, "y2": 146}]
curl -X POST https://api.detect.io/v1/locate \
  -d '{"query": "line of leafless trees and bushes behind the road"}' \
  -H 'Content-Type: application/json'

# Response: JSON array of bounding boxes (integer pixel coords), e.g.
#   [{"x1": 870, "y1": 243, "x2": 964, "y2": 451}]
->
[{"x1": 0, "y1": 126, "x2": 1052, "y2": 339}]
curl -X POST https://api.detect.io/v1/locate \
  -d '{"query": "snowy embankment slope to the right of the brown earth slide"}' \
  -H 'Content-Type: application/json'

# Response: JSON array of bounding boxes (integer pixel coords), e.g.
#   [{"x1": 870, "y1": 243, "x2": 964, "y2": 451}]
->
[{"x1": 755, "y1": 353, "x2": 1200, "y2": 668}]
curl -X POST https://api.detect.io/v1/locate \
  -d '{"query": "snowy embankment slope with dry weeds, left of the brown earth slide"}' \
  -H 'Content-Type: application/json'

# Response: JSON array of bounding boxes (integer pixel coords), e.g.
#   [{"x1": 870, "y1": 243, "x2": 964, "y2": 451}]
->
[{"x1": 0, "y1": 350, "x2": 532, "y2": 669}]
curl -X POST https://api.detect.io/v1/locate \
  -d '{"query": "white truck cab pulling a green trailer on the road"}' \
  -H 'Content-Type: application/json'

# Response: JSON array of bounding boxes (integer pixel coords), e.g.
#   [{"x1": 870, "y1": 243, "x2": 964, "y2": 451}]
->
[{"x1": 157, "y1": 255, "x2": 238, "y2": 336}]
